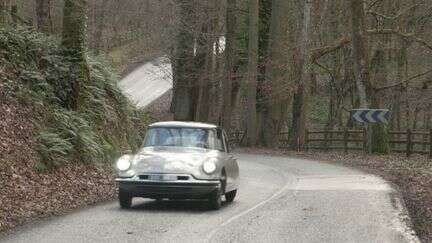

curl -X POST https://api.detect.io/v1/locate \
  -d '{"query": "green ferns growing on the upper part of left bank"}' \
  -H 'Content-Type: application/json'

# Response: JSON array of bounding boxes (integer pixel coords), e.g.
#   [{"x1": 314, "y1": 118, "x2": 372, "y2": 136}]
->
[{"x1": 0, "y1": 28, "x2": 149, "y2": 171}]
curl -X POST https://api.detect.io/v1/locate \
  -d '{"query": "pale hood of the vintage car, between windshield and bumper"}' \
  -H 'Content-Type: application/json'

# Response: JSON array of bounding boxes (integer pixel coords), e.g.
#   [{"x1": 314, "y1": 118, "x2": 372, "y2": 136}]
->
[{"x1": 132, "y1": 147, "x2": 218, "y2": 177}]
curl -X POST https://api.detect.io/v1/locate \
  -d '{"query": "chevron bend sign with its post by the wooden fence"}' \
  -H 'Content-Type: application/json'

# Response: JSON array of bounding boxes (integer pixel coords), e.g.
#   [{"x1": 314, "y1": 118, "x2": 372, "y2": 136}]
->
[{"x1": 351, "y1": 109, "x2": 390, "y2": 154}]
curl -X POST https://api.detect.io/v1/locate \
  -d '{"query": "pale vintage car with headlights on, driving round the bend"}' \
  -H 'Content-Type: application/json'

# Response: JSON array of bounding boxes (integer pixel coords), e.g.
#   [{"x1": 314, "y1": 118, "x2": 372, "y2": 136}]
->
[{"x1": 116, "y1": 122, "x2": 239, "y2": 209}]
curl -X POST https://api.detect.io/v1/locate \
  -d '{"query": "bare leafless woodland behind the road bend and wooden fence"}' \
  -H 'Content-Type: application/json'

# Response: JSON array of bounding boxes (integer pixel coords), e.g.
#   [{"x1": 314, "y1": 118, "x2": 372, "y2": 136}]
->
[{"x1": 1, "y1": 0, "x2": 432, "y2": 151}]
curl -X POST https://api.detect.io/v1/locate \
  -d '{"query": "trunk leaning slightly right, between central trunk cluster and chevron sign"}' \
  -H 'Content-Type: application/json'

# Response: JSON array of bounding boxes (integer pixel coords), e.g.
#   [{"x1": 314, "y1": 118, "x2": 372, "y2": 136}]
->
[{"x1": 290, "y1": 1, "x2": 313, "y2": 149}]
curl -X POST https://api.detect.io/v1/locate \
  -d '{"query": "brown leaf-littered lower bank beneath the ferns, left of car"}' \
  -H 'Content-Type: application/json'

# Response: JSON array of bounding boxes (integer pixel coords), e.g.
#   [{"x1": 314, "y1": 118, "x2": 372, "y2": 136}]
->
[{"x1": 0, "y1": 97, "x2": 115, "y2": 232}]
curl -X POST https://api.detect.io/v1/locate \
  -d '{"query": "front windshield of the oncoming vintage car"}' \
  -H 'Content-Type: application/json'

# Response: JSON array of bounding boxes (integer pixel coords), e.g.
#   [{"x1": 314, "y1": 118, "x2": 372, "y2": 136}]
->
[{"x1": 144, "y1": 127, "x2": 223, "y2": 150}]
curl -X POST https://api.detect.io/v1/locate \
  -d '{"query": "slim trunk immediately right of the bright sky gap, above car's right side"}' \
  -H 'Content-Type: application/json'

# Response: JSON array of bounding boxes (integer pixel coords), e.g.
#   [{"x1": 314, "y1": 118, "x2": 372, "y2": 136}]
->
[{"x1": 221, "y1": 0, "x2": 237, "y2": 133}]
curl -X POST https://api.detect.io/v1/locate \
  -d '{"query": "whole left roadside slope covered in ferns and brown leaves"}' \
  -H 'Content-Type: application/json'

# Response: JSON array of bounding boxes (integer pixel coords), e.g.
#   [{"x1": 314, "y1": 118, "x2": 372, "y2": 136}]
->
[{"x1": 0, "y1": 29, "x2": 149, "y2": 232}]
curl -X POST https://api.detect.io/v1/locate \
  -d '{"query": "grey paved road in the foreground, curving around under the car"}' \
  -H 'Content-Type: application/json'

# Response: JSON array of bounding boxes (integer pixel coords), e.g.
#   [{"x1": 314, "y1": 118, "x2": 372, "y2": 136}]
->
[{"x1": 0, "y1": 154, "x2": 416, "y2": 243}]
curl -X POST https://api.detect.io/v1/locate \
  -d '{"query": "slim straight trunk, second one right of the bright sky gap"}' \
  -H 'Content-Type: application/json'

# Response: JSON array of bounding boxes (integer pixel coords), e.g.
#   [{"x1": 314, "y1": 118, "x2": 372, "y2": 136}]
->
[{"x1": 246, "y1": 0, "x2": 259, "y2": 146}]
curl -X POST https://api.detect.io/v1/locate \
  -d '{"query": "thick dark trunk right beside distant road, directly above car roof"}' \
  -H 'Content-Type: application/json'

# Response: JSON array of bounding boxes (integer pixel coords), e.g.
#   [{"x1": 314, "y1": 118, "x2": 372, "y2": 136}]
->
[{"x1": 172, "y1": 0, "x2": 195, "y2": 121}]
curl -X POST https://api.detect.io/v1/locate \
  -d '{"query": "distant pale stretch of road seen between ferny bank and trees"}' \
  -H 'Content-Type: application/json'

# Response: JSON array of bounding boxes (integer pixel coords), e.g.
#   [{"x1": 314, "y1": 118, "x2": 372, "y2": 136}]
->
[{"x1": 120, "y1": 57, "x2": 173, "y2": 108}]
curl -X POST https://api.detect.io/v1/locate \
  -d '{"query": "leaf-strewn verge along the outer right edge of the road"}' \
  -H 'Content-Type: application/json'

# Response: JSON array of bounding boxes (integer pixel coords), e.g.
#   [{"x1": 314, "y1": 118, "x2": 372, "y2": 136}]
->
[{"x1": 238, "y1": 149, "x2": 426, "y2": 242}]
